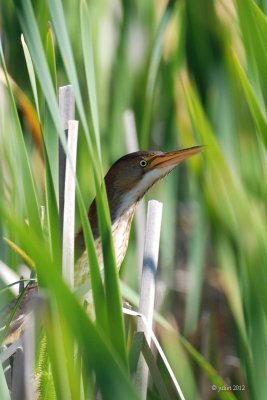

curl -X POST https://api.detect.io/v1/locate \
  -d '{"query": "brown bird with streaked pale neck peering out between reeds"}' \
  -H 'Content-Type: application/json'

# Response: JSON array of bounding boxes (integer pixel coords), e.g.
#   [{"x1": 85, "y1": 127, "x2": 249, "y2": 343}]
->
[{"x1": 74, "y1": 146, "x2": 205, "y2": 294}]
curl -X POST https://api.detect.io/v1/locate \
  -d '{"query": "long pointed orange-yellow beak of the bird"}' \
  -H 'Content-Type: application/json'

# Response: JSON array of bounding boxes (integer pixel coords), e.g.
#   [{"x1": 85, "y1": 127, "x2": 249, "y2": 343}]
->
[{"x1": 149, "y1": 146, "x2": 206, "y2": 169}]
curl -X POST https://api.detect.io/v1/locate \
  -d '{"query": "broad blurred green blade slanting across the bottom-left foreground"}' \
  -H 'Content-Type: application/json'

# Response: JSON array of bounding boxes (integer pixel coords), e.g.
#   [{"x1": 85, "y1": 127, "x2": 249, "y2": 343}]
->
[{"x1": 0, "y1": 203, "x2": 138, "y2": 400}]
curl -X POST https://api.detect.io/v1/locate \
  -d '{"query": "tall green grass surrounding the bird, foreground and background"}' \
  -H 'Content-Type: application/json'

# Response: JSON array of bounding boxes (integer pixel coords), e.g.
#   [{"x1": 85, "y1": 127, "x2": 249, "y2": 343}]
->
[{"x1": 0, "y1": 0, "x2": 267, "y2": 399}]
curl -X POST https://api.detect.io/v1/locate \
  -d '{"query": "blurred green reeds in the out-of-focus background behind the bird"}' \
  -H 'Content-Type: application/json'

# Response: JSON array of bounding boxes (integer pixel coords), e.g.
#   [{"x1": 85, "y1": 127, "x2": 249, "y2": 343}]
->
[{"x1": 0, "y1": 0, "x2": 267, "y2": 399}]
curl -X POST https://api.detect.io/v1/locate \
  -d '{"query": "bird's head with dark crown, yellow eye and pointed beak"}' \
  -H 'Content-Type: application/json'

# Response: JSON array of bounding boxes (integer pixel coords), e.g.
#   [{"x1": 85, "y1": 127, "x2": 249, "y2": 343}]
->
[{"x1": 105, "y1": 146, "x2": 204, "y2": 218}]
